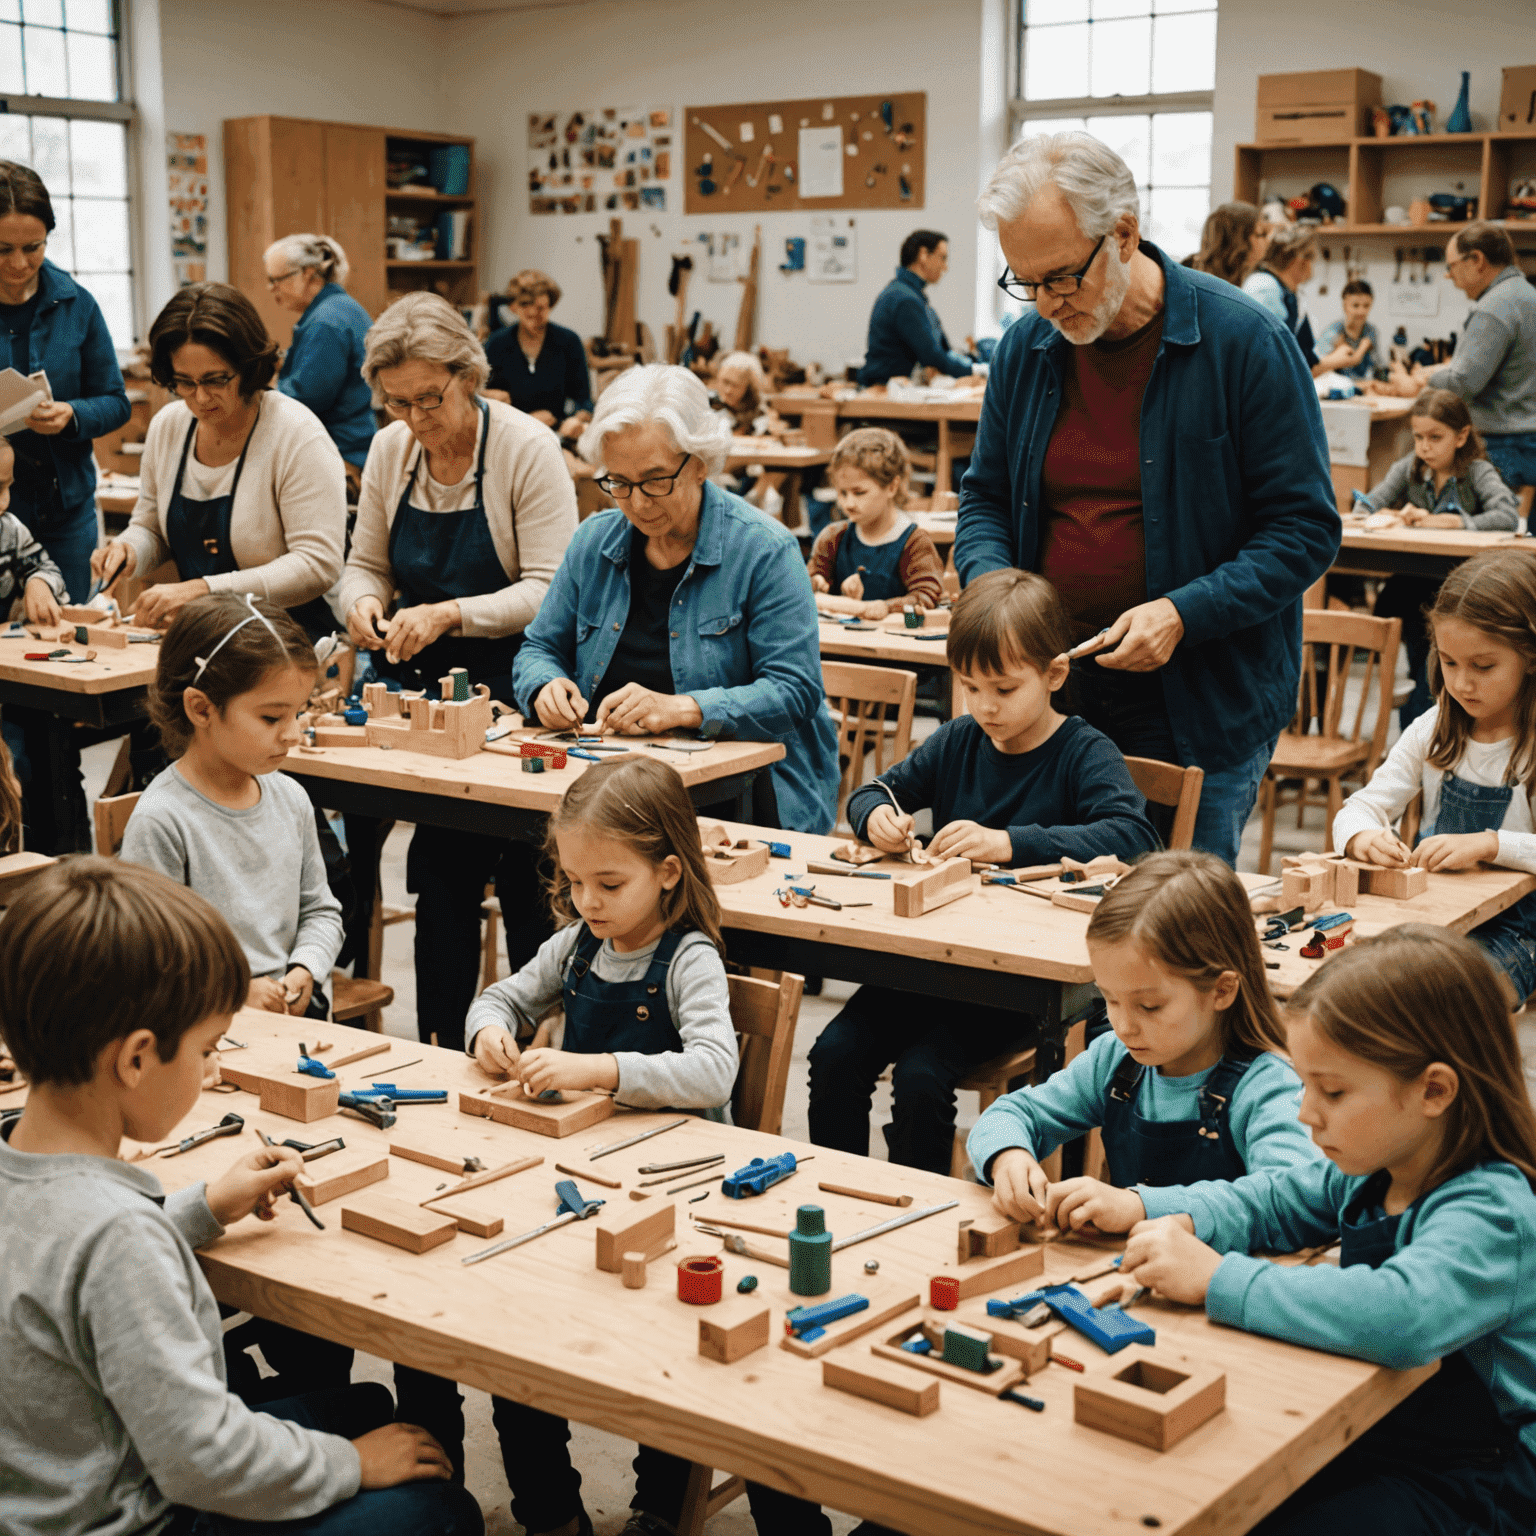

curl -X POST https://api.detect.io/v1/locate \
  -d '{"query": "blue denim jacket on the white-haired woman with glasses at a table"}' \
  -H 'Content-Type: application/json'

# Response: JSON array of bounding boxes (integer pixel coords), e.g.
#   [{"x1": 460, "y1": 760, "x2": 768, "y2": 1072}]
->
[{"x1": 511, "y1": 482, "x2": 839, "y2": 833}]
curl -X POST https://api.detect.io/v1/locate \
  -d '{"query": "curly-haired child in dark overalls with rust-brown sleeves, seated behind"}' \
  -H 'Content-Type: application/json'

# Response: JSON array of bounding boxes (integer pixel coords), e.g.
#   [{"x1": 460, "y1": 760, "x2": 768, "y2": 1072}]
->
[{"x1": 806, "y1": 427, "x2": 945, "y2": 619}]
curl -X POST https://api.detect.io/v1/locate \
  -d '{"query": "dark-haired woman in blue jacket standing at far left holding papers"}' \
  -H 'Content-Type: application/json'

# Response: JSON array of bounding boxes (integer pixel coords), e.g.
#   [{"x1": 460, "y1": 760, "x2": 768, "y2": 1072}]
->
[{"x1": 0, "y1": 160, "x2": 129, "y2": 602}]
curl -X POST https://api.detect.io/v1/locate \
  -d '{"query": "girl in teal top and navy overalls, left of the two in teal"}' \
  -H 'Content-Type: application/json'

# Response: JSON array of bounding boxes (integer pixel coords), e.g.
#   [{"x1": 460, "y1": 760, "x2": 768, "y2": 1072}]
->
[{"x1": 968, "y1": 852, "x2": 1318, "y2": 1232}]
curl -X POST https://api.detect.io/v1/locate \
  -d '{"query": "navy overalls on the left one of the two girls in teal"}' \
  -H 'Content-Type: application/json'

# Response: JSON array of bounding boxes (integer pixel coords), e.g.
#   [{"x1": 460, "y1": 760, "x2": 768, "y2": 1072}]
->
[{"x1": 1103, "y1": 1055, "x2": 1255, "y2": 1189}]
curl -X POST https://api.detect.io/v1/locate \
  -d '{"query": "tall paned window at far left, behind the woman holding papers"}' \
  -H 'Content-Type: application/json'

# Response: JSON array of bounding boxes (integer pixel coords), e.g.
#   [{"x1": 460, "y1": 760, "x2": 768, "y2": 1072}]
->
[{"x1": 0, "y1": 0, "x2": 134, "y2": 347}]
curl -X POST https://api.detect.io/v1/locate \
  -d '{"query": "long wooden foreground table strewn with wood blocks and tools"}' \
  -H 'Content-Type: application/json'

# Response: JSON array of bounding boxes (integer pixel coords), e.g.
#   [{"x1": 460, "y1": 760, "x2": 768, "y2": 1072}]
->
[{"x1": 129, "y1": 1007, "x2": 1435, "y2": 1536}]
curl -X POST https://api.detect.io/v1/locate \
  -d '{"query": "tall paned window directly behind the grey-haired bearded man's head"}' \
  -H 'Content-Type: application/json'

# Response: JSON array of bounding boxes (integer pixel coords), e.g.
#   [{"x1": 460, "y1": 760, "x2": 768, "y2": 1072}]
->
[{"x1": 1011, "y1": 0, "x2": 1217, "y2": 260}]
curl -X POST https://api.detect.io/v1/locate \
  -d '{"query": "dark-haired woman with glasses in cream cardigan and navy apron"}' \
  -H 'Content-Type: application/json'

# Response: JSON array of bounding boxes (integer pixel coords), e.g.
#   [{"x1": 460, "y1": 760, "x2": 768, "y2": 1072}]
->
[{"x1": 91, "y1": 283, "x2": 347, "y2": 639}]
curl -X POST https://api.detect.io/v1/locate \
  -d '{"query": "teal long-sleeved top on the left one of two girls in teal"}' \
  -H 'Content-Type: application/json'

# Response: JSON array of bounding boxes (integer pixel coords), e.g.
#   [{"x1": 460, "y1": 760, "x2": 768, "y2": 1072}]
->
[{"x1": 966, "y1": 1034, "x2": 1322, "y2": 1193}]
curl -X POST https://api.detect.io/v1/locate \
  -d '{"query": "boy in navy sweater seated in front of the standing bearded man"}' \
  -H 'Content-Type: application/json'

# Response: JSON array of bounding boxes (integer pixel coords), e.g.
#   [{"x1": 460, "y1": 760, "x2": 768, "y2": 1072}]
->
[{"x1": 811, "y1": 570, "x2": 1158, "y2": 1174}]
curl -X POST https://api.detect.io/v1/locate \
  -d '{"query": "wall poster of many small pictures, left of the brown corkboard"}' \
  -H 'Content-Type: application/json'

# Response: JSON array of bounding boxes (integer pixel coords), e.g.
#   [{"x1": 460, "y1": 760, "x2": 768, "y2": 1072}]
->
[{"x1": 528, "y1": 106, "x2": 673, "y2": 214}]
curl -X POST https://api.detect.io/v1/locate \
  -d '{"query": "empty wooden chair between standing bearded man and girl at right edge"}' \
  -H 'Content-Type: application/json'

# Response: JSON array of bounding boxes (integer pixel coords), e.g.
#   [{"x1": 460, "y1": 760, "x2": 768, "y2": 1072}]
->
[{"x1": 1258, "y1": 608, "x2": 1402, "y2": 874}]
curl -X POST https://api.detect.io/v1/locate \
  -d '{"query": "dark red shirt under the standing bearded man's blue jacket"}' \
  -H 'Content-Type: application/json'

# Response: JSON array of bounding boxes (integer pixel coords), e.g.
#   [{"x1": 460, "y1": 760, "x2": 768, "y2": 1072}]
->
[{"x1": 1038, "y1": 310, "x2": 1163, "y2": 639}]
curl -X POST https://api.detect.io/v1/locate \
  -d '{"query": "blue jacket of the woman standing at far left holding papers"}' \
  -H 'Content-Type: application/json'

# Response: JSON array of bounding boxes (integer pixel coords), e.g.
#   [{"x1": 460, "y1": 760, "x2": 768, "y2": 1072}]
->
[{"x1": 11, "y1": 261, "x2": 132, "y2": 528}]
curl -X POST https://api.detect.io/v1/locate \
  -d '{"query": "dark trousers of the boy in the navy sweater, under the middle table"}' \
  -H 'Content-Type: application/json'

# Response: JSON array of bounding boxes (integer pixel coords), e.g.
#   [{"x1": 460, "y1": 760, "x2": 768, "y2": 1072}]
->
[{"x1": 811, "y1": 986, "x2": 1038, "y2": 1174}]
